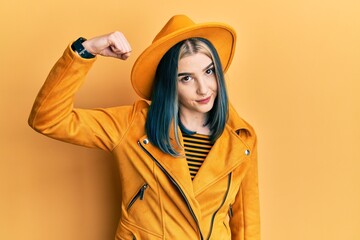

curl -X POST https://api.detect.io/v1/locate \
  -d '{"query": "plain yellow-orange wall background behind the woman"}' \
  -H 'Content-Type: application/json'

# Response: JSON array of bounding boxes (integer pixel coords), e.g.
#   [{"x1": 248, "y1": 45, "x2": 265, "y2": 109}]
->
[{"x1": 0, "y1": 0, "x2": 360, "y2": 240}]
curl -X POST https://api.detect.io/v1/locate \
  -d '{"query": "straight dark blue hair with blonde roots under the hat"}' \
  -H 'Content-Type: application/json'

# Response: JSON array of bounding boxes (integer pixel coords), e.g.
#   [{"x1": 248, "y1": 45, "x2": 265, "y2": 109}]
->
[{"x1": 145, "y1": 38, "x2": 229, "y2": 156}]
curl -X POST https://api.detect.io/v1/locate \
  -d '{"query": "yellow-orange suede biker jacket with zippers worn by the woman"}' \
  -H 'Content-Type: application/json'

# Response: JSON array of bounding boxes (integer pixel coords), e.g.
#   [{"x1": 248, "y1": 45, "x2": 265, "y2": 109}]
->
[{"x1": 29, "y1": 47, "x2": 260, "y2": 240}]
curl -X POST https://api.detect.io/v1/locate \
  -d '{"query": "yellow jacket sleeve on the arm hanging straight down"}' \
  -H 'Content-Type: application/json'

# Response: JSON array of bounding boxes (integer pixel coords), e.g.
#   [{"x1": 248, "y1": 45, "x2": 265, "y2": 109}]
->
[{"x1": 230, "y1": 133, "x2": 260, "y2": 240}]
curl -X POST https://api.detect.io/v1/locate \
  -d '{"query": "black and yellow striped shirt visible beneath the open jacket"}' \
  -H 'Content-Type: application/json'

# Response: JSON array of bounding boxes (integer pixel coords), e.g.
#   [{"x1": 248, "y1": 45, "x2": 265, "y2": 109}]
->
[{"x1": 183, "y1": 132, "x2": 213, "y2": 180}]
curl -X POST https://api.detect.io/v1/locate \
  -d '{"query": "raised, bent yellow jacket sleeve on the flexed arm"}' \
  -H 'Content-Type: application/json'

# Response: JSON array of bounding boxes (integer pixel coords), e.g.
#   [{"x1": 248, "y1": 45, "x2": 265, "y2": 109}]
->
[{"x1": 28, "y1": 46, "x2": 133, "y2": 151}]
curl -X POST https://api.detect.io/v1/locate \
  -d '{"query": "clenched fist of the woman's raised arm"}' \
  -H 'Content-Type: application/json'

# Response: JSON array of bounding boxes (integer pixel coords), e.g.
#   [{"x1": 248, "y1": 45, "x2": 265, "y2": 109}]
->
[{"x1": 82, "y1": 31, "x2": 131, "y2": 60}]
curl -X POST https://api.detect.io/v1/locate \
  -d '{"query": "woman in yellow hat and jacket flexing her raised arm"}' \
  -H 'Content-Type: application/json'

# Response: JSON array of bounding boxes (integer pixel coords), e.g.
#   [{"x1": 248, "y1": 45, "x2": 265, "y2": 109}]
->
[{"x1": 29, "y1": 15, "x2": 260, "y2": 240}]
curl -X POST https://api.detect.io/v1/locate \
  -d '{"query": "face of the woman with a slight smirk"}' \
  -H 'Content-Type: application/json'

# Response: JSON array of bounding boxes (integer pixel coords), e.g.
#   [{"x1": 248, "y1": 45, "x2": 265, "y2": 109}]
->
[{"x1": 177, "y1": 53, "x2": 217, "y2": 119}]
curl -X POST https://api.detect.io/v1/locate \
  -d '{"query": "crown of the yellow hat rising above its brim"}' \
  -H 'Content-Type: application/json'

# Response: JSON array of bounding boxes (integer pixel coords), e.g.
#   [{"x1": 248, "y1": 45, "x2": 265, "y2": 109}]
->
[{"x1": 153, "y1": 15, "x2": 195, "y2": 43}]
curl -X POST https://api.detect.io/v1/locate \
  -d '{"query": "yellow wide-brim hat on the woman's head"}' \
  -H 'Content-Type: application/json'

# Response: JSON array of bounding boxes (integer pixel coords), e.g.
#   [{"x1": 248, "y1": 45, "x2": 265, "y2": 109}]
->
[{"x1": 131, "y1": 15, "x2": 236, "y2": 100}]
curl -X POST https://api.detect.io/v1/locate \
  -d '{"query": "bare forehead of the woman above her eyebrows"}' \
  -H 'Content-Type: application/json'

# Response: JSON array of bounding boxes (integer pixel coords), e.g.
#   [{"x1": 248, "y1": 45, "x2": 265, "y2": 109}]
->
[{"x1": 178, "y1": 53, "x2": 213, "y2": 72}]
